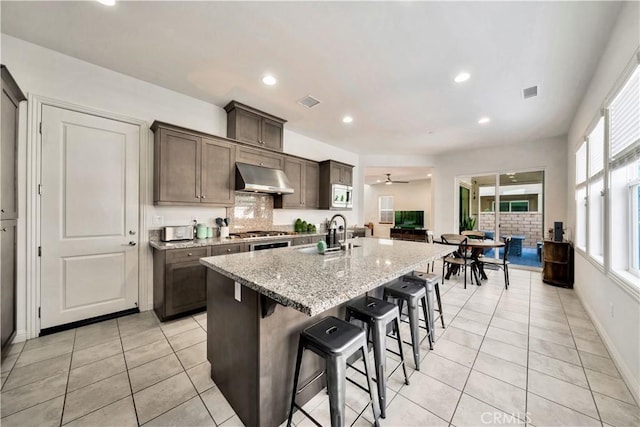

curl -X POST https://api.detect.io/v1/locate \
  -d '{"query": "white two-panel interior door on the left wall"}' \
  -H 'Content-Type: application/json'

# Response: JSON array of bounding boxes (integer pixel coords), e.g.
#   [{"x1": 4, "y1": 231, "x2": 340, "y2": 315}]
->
[{"x1": 40, "y1": 105, "x2": 140, "y2": 329}]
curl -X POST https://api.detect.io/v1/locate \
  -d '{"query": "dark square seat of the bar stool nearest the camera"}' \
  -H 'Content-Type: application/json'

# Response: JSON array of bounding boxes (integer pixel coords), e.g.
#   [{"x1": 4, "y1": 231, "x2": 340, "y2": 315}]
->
[{"x1": 302, "y1": 316, "x2": 365, "y2": 355}]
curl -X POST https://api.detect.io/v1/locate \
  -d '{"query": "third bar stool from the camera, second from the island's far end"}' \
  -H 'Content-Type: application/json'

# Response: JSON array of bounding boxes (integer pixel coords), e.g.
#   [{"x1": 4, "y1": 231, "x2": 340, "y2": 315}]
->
[{"x1": 384, "y1": 276, "x2": 433, "y2": 371}]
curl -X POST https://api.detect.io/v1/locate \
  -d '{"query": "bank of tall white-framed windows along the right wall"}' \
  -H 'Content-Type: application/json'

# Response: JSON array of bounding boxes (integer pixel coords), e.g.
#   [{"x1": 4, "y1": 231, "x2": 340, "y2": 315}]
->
[{"x1": 575, "y1": 59, "x2": 640, "y2": 291}]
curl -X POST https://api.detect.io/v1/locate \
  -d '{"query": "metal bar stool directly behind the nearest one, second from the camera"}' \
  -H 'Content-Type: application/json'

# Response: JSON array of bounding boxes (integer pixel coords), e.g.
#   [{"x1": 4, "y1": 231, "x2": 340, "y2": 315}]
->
[{"x1": 346, "y1": 296, "x2": 409, "y2": 418}]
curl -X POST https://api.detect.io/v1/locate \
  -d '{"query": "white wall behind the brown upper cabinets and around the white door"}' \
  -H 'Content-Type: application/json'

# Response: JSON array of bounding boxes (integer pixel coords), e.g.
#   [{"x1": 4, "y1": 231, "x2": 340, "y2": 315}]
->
[{"x1": 1, "y1": 34, "x2": 361, "y2": 334}]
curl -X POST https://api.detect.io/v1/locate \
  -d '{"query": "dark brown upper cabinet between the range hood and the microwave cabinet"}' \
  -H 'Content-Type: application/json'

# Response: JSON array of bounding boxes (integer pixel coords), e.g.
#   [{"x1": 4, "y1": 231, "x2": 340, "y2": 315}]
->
[{"x1": 273, "y1": 156, "x2": 319, "y2": 209}]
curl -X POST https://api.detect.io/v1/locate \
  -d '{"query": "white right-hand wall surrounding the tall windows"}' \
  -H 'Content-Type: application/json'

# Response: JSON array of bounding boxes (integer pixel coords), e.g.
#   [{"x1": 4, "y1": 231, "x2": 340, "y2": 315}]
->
[{"x1": 567, "y1": 2, "x2": 640, "y2": 401}]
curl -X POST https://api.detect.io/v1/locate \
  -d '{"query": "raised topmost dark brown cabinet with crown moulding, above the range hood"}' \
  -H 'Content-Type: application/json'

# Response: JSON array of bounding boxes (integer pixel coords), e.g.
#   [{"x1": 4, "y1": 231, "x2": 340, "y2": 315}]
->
[{"x1": 224, "y1": 101, "x2": 287, "y2": 151}]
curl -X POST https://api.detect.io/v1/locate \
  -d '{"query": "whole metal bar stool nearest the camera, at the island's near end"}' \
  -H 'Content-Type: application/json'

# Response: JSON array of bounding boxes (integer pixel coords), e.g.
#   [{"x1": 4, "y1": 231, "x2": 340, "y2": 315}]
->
[{"x1": 287, "y1": 316, "x2": 380, "y2": 427}]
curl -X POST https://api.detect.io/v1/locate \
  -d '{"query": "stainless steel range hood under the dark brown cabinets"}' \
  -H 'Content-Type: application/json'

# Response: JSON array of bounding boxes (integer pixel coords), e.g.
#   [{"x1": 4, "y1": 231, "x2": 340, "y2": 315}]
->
[{"x1": 236, "y1": 163, "x2": 293, "y2": 194}]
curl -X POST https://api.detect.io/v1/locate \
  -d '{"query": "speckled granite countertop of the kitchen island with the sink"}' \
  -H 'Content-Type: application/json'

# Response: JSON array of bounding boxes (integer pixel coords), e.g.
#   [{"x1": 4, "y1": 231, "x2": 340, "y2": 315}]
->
[{"x1": 200, "y1": 238, "x2": 451, "y2": 316}]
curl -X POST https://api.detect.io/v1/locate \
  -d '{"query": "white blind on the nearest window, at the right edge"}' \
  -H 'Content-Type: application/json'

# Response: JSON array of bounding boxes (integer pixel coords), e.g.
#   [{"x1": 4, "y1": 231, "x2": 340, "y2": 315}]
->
[{"x1": 609, "y1": 66, "x2": 640, "y2": 166}]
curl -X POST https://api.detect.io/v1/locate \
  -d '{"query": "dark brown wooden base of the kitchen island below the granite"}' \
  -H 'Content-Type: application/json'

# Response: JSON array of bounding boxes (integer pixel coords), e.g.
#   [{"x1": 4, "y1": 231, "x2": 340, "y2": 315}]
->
[{"x1": 207, "y1": 270, "x2": 345, "y2": 426}]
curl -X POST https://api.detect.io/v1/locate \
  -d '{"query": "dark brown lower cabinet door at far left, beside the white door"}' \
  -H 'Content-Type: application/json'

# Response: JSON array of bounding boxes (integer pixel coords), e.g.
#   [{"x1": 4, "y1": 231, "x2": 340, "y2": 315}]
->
[{"x1": 0, "y1": 220, "x2": 18, "y2": 349}]
